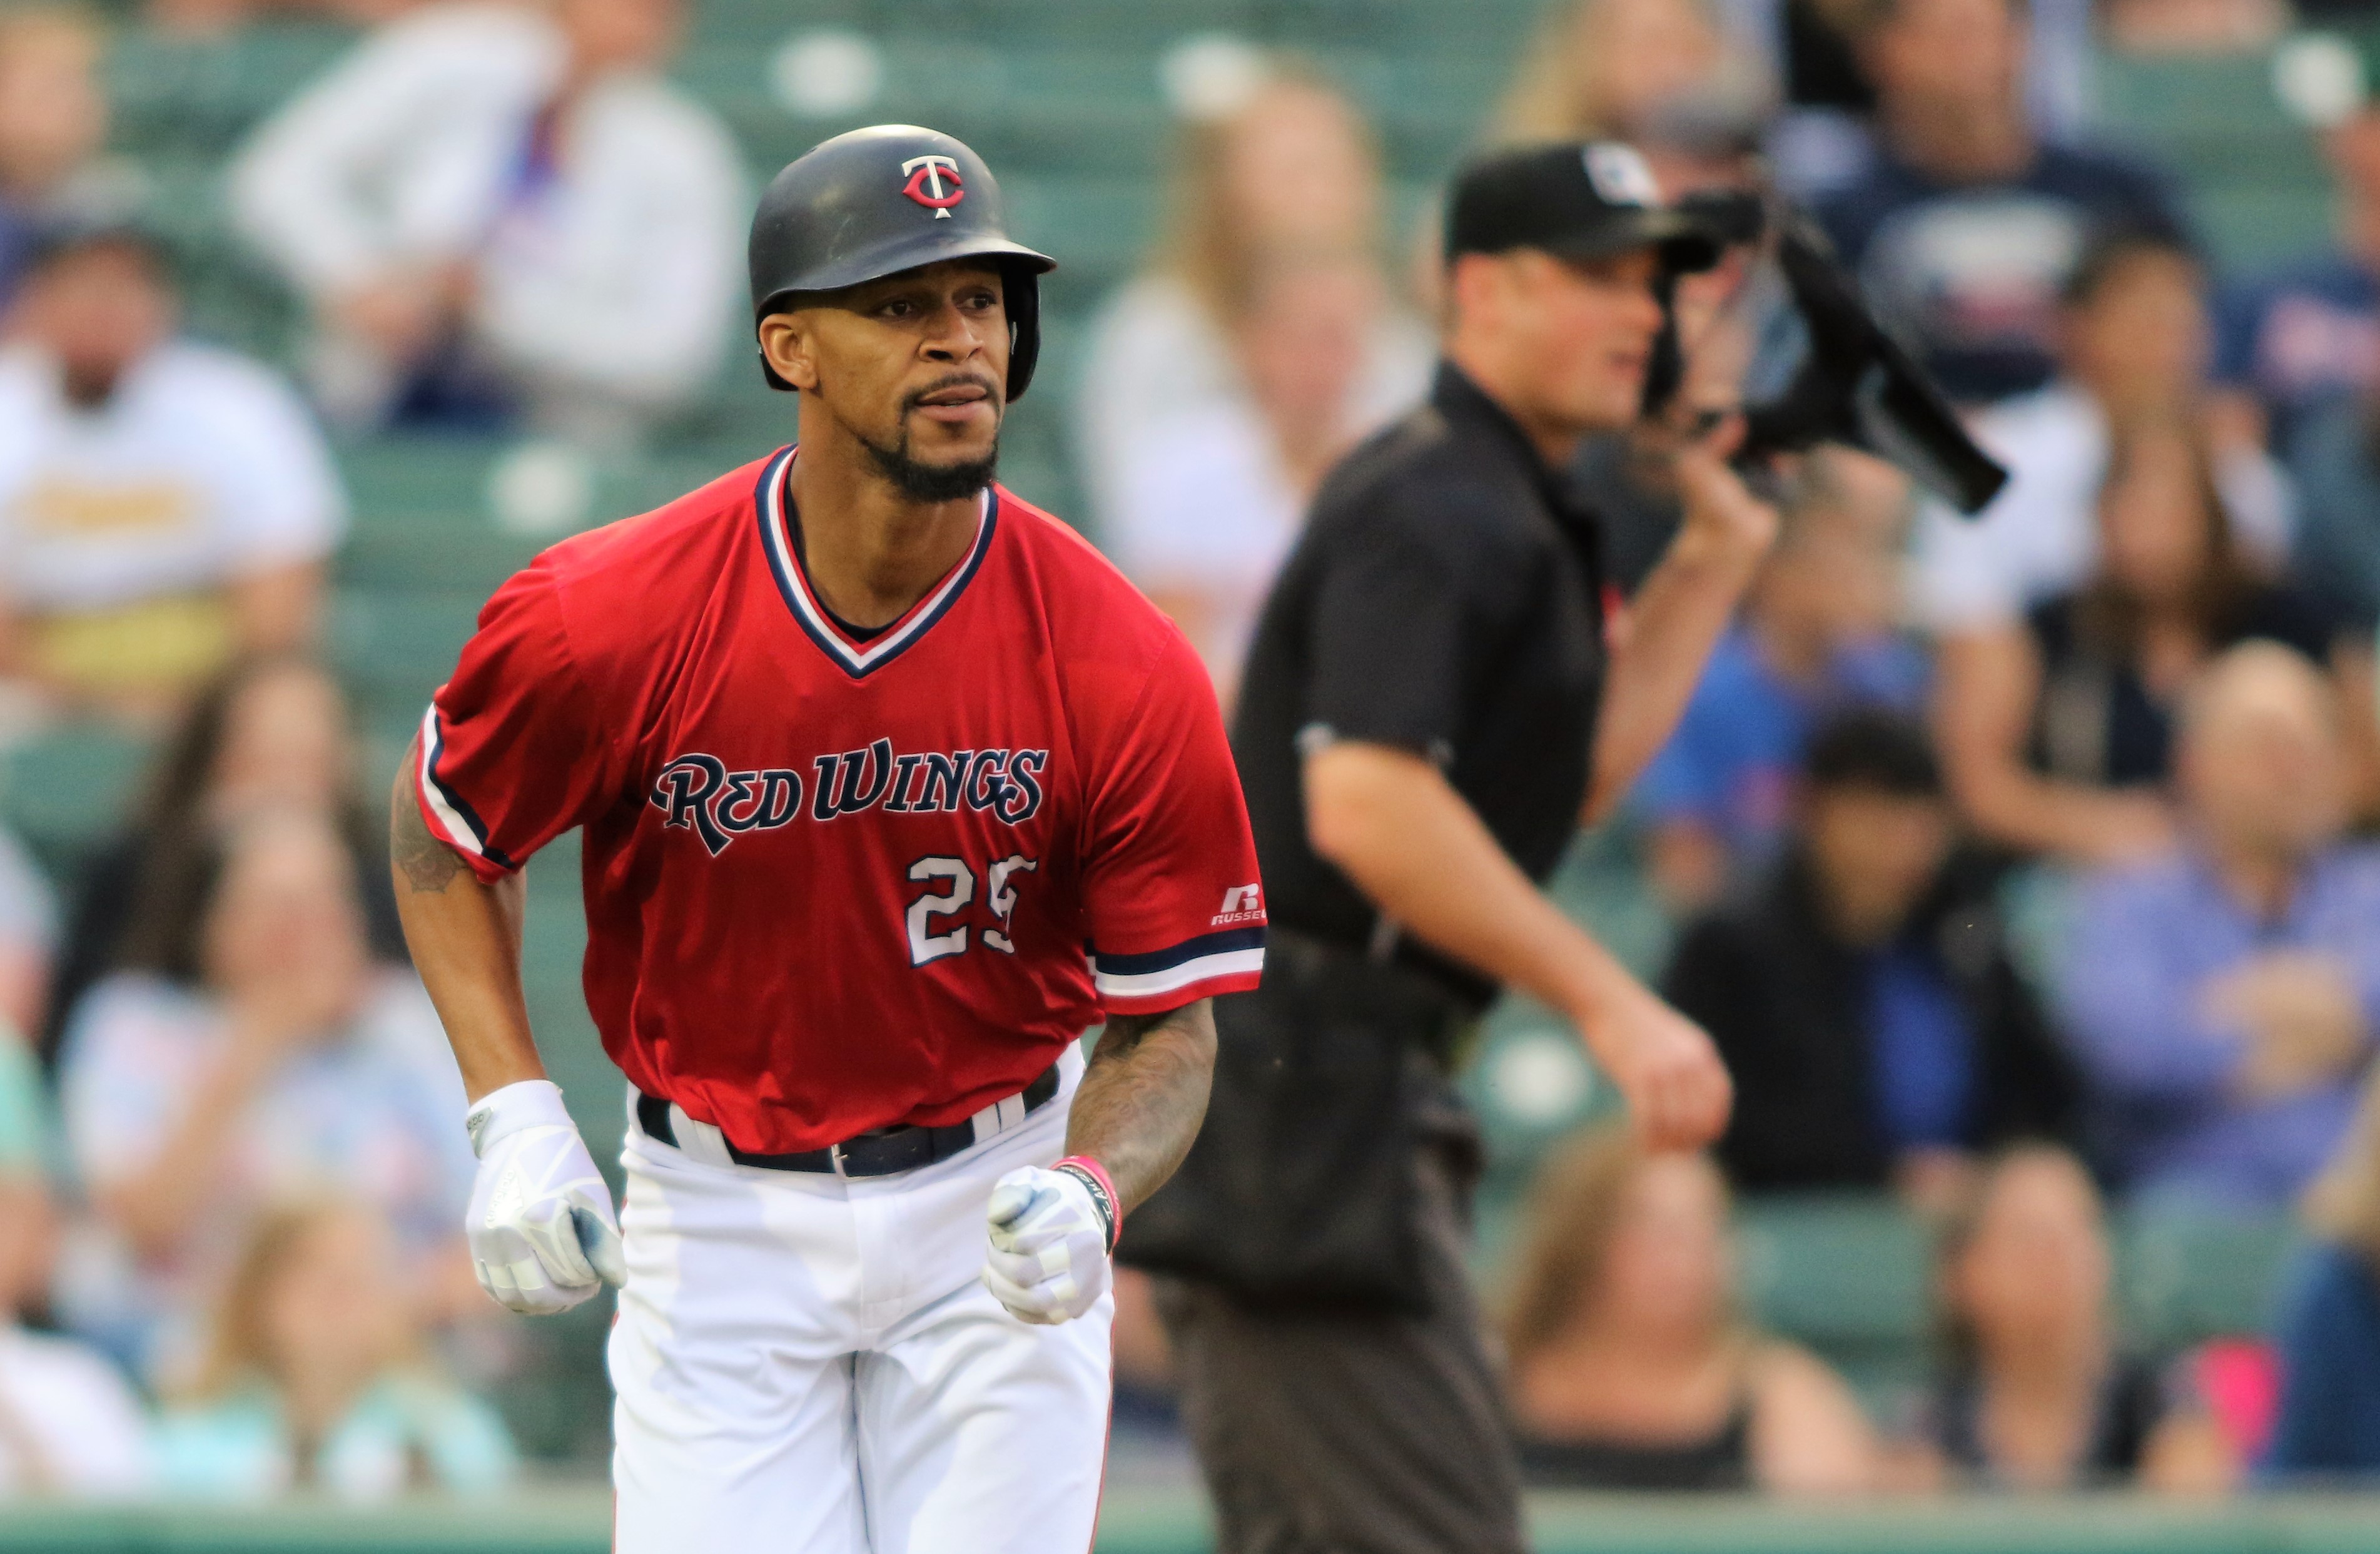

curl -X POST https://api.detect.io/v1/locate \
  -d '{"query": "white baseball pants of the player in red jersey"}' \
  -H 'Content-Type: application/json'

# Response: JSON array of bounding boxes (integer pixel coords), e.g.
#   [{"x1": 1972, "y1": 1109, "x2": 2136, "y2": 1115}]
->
[{"x1": 609, "y1": 1052, "x2": 1114, "y2": 1554}]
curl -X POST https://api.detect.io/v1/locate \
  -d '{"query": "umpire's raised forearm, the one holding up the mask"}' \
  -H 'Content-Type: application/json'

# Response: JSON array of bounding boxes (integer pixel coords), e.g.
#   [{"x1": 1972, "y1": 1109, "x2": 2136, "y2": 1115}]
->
[{"x1": 1581, "y1": 531, "x2": 1759, "y2": 826}]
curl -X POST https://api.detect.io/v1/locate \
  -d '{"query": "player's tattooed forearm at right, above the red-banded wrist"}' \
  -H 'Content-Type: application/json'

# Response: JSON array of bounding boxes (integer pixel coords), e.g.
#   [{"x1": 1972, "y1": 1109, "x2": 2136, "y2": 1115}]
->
[{"x1": 1066, "y1": 1000, "x2": 1214, "y2": 1214}]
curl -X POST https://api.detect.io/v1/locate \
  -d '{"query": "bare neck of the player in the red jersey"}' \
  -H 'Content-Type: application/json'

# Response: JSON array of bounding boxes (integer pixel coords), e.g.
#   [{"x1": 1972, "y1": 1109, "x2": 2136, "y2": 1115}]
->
[{"x1": 787, "y1": 440, "x2": 983, "y2": 628}]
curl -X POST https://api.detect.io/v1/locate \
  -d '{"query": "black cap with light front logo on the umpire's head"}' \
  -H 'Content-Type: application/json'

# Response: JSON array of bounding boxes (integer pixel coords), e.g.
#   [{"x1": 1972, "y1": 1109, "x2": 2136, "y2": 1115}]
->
[{"x1": 1447, "y1": 140, "x2": 1723, "y2": 273}]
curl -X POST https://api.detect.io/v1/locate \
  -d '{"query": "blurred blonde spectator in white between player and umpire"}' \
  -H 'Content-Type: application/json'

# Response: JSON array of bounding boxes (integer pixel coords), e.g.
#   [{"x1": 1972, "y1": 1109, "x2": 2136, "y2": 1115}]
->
[{"x1": 1076, "y1": 67, "x2": 1433, "y2": 698}]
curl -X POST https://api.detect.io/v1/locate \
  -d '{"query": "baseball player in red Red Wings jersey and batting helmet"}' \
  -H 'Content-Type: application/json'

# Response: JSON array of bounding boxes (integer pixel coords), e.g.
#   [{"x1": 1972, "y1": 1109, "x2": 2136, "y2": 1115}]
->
[{"x1": 393, "y1": 126, "x2": 1263, "y2": 1554}]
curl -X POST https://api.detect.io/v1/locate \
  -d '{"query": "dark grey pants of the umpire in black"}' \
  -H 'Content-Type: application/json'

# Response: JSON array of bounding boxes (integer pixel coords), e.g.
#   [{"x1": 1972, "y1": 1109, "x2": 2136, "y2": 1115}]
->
[{"x1": 1157, "y1": 1145, "x2": 1526, "y2": 1554}]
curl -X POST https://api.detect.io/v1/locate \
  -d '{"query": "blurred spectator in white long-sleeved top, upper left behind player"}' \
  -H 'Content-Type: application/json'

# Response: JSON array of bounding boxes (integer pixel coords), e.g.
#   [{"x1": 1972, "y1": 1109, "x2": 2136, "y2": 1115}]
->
[{"x1": 231, "y1": 0, "x2": 747, "y2": 450}]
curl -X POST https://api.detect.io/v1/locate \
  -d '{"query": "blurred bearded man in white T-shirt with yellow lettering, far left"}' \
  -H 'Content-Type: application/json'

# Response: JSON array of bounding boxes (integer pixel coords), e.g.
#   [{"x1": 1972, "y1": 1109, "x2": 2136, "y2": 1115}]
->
[{"x1": 0, "y1": 226, "x2": 345, "y2": 711}]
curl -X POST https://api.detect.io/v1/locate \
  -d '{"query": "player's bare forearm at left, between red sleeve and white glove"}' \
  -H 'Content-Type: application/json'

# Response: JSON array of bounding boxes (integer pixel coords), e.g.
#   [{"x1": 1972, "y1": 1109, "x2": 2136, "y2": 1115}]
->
[{"x1": 388, "y1": 743, "x2": 545, "y2": 1102}]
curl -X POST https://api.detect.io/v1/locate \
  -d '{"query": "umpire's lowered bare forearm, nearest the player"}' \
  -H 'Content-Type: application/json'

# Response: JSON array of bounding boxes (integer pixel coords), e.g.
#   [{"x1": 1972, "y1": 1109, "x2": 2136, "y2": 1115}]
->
[{"x1": 1307, "y1": 743, "x2": 1642, "y2": 1033}]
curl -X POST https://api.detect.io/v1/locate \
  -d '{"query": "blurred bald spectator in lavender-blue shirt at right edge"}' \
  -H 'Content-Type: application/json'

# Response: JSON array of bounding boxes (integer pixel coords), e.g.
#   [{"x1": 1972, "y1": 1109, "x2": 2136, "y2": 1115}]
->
[{"x1": 2058, "y1": 642, "x2": 2380, "y2": 1207}]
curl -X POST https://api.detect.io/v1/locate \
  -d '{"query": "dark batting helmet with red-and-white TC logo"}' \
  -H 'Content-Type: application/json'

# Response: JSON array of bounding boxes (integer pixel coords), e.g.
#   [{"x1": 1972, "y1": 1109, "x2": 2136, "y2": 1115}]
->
[{"x1": 752, "y1": 124, "x2": 1056, "y2": 400}]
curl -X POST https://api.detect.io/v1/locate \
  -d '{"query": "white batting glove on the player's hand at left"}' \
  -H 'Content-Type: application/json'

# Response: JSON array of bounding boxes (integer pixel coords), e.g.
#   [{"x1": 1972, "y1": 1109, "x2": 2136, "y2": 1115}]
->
[{"x1": 462, "y1": 1078, "x2": 629, "y2": 1316}]
